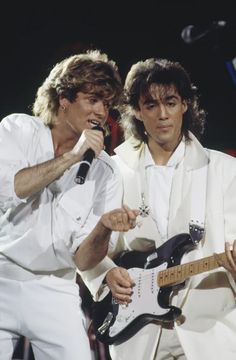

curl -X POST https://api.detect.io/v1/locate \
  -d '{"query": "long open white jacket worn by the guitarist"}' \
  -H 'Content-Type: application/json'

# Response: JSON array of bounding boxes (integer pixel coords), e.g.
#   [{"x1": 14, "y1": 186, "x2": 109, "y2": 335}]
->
[{"x1": 80, "y1": 134, "x2": 236, "y2": 360}]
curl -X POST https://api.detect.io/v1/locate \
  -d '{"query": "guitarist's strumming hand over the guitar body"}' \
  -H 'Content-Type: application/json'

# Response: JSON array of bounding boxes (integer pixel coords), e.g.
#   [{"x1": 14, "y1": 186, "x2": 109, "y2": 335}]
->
[{"x1": 106, "y1": 267, "x2": 135, "y2": 305}]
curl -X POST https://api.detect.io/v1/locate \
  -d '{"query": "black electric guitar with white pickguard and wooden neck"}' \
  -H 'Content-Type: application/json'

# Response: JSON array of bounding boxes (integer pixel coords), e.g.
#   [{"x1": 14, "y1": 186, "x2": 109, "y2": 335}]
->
[{"x1": 92, "y1": 233, "x2": 227, "y2": 345}]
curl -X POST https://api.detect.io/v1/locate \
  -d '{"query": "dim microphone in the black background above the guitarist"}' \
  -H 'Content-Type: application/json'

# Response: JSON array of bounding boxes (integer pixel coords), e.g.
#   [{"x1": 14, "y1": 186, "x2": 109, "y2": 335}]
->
[{"x1": 181, "y1": 20, "x2": 226, "y2": 44}]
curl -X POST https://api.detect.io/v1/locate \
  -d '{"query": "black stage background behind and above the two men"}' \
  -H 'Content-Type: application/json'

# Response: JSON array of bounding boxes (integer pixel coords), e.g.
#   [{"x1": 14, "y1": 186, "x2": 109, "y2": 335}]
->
[{"x1": 0, "y1": 0, "x2": 236, "y2": 150}]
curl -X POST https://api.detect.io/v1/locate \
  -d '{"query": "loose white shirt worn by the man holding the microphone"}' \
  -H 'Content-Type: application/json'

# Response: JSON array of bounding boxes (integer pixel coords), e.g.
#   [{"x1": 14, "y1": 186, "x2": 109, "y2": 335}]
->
[{"x1": 0, "y1": 114, "x2": 122, "y2": 278}]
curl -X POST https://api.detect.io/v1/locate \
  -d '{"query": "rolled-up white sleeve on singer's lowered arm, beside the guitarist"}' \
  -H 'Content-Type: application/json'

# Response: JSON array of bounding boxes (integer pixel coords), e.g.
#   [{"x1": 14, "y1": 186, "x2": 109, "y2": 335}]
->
[{"x1": 53, "y1": 160, "x2": 122, "y2": 270}]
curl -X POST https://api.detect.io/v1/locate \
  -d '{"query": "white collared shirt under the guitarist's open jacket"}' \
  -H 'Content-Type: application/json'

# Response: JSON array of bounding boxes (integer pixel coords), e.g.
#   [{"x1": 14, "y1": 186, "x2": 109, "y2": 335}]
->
[{"x1": 144, "y1": 141, "x2": 185, "y2": 240}]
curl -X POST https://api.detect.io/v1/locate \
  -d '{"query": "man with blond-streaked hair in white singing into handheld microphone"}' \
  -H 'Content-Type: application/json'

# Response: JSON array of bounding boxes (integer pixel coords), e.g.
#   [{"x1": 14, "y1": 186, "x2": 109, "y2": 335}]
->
[{"x1": 0, "y1": 50, "x2": 137, "y2": 360}]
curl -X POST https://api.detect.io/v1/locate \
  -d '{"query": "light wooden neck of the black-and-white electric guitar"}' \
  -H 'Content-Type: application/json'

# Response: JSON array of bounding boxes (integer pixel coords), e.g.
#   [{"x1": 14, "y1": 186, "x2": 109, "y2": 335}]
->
[{"x1": 157, "y1": 253, "x2": 227, "y2": 287}]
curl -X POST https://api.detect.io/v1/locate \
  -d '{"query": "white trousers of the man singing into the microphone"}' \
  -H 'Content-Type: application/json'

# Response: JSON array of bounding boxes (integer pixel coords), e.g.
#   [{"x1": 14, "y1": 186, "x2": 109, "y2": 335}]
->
[{"x1": 0, "y1": 275, "x2": 92, "y2": 360}]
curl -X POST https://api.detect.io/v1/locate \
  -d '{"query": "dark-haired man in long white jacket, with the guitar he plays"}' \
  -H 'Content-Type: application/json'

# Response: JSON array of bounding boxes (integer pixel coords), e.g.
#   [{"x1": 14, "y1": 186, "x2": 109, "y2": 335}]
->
[{"x1": 84, "y1": 58, "x2": 236, "y2": 360}]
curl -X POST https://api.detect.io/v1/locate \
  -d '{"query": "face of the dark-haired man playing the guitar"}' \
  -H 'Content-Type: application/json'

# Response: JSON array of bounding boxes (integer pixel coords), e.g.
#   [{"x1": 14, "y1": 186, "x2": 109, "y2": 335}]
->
[{"x1": 136, "y1": 84, "x2": 187, "y2": 149}]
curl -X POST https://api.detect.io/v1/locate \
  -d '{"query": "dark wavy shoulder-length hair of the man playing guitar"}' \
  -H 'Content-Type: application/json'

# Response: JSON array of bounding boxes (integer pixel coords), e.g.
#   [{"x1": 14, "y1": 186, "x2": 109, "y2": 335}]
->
[{"x1": 120, "y1": 58, "x2": 206, "y2": 142}]
